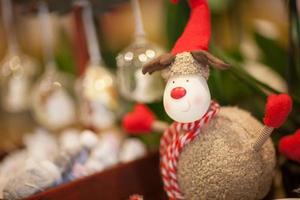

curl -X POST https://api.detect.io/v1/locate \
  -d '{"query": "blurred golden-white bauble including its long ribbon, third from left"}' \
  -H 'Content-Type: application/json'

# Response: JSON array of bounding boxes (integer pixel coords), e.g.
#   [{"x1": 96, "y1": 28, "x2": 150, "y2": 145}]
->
[{"x1": 75, "y1": 0, "x2": 118, "y2": 130}]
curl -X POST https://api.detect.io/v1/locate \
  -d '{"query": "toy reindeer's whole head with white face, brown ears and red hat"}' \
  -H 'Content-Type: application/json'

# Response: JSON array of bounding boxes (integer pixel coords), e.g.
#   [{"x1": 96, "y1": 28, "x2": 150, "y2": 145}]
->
[{"x1": 139, "y1": 0, "x2": 229, "y2": 123}]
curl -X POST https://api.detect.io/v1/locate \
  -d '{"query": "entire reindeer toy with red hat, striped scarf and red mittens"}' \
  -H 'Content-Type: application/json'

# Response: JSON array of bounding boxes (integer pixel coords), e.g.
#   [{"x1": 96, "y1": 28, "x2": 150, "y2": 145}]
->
[{"x1": 123, "y1": 0, "x2": 292, "y2": 200}]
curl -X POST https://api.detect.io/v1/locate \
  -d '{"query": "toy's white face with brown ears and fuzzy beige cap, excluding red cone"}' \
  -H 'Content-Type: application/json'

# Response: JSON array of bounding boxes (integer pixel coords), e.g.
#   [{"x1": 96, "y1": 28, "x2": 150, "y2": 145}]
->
[{"x1": 143, "y1": 50, "x2": 229, "y2": 123}]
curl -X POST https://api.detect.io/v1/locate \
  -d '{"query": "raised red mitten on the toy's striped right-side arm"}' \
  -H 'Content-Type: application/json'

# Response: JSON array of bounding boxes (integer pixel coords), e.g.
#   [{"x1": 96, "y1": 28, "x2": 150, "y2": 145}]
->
[{"x1": 264, "y1": 94, "x2": 293, "y2": 128}]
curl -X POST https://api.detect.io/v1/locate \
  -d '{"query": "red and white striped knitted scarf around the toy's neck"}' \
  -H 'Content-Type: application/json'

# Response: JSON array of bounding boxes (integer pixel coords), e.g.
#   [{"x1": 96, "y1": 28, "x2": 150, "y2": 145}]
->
[{"x1": 160, "y1": 101, "x2": 220, "y2": 200}]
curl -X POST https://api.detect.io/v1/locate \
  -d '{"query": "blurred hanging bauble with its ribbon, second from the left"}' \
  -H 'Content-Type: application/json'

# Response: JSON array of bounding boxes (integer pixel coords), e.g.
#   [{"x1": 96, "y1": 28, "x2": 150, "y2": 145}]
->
[{"x1": 32, "y1": 2, "x2": 76, "y2": 129}]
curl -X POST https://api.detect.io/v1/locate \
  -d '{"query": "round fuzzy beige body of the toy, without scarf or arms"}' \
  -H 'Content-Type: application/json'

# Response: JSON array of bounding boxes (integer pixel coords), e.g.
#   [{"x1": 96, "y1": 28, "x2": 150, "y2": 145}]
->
[{"x1": 177, "y1": 107, "x2": 275, "y2": 200}]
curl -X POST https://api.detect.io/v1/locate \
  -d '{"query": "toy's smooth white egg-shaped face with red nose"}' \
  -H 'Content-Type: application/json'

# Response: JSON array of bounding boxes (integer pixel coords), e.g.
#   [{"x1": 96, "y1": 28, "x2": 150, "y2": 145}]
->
[{"x1": 164, "y1": 74, "x2": 211, "y2": 123}]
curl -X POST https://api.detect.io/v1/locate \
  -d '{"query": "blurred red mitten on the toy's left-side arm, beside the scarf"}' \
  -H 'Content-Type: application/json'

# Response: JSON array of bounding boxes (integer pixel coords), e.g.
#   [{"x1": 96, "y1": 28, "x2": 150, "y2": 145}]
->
[{"x1": 122, "y1": 104, "x2": 155, "y2": 135}]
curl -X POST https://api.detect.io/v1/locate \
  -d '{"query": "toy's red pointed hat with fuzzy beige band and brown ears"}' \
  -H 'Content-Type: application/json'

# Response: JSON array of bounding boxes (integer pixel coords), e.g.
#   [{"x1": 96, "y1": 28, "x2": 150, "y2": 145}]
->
[{"x1": 143, "y1": 0, "x2": 229, "y2": 79}]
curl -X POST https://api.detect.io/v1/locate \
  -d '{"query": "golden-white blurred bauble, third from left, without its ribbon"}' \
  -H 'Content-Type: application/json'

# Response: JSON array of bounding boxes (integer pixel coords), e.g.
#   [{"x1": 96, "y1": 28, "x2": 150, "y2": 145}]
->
[{"x1": 76, "y1": 65, "x2": 118, "y2": 130}]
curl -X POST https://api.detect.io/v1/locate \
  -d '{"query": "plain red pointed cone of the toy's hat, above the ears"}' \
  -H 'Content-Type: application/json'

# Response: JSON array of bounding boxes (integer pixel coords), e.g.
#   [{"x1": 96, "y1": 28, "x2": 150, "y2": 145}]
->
[{"x1": 172, "y1": 0, "x2": 211, "y2": 54}]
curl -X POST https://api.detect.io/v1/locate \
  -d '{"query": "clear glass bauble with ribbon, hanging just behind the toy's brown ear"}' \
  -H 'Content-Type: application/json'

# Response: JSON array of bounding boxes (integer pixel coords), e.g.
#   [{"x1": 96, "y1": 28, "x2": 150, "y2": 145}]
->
[{"x1": 116, "y1": 0, "x2": 164, "y2": 103}]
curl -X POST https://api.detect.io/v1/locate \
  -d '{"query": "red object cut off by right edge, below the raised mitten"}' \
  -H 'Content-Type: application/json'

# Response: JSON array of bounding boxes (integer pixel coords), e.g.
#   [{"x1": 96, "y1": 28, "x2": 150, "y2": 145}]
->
[{"x1": 279, "y1": 129, "x2": 300, "y2": 163}]
